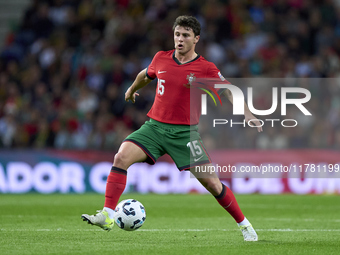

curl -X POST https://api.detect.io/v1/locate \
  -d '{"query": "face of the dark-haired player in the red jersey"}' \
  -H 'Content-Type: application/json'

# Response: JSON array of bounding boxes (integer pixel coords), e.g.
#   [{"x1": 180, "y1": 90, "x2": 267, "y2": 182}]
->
[{"x1": 174, "y1": 26, "x2": 199, "y2": 55}]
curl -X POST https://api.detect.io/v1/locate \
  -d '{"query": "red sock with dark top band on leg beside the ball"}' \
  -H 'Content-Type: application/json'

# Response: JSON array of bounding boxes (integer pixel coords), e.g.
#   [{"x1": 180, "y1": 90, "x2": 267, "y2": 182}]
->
[{"x1": 104, "y1": 166, "x2": 127, "y2": 210}]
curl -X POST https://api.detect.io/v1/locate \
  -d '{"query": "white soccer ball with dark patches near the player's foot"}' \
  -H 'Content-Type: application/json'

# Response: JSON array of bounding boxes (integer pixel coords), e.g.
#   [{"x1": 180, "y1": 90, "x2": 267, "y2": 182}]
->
[{"x1": 114, "y1": 199, "x2": 146, "y2": 231}]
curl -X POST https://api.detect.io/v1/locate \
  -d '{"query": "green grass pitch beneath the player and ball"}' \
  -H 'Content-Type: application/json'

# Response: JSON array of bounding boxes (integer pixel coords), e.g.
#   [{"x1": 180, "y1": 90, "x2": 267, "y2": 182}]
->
[{"x1": 0, "y1": 194, "x2": 340, "y2": 255}]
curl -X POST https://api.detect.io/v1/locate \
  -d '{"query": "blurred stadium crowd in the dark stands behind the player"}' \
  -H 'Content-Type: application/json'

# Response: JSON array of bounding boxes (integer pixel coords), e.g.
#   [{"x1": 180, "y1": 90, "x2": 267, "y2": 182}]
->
[{"x1": 0, "y1": 0, "x2": 340, "y2": 150}]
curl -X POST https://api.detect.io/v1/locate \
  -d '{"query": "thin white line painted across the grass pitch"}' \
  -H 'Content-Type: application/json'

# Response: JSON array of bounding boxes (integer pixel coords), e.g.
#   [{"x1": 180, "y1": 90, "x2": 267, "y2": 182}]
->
[{"x1": 0, "y1": 228, "x2": 340, "y2": 232}]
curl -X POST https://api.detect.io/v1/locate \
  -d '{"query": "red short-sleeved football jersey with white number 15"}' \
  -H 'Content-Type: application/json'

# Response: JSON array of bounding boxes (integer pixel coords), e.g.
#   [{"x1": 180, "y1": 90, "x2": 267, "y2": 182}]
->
[{"x1": 146, "y1": 50, "x2": 224, "y2": 125}]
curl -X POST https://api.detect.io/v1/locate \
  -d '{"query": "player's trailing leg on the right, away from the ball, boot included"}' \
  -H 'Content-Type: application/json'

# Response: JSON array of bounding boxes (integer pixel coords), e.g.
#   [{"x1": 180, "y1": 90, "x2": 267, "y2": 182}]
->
[{"x1": 190, "y1": 164, "x2": 258, "y2": 241}]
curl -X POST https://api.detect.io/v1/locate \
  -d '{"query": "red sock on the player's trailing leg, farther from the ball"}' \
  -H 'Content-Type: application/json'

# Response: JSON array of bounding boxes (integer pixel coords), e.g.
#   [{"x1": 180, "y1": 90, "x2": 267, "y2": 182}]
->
[{"x1": 215, "y1": 184, "x2": 244, "y2": 223}]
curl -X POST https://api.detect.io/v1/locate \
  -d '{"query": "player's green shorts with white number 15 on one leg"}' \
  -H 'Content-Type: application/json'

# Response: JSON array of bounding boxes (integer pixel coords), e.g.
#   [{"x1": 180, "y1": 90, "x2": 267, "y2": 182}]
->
[{"x1": 124, "y1": 119, "x2": 211, "y2": 171}]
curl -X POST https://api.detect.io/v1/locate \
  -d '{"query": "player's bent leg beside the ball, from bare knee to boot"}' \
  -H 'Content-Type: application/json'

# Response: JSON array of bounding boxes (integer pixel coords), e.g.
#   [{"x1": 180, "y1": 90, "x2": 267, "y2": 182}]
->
[{"x1": 82, "y1": 142, "x2": 147, "y2": 231}]
